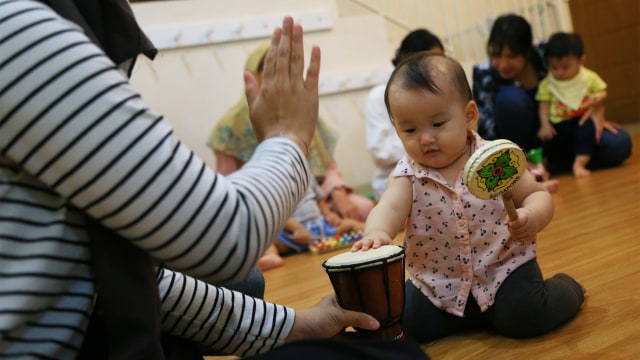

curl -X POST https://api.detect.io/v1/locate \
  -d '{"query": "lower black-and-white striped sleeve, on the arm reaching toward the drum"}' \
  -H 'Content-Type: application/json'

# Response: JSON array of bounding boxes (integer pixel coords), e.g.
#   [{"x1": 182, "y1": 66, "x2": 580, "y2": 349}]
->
[{"x1": 158, "y1": 269, "x2": 295, "y2": 357}]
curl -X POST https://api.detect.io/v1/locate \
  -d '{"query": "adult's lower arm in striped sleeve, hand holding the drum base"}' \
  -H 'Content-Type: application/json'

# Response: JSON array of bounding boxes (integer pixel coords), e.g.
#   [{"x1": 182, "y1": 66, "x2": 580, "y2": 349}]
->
[{"x1": 158, "y1": 269, "x2": 379, "y2": 357}]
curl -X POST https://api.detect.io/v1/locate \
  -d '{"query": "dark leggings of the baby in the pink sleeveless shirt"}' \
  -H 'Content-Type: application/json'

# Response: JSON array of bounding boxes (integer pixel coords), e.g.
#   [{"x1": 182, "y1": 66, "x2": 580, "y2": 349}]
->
[{"x1": 402, "y1": 259, "x2": 584, "y2": 343}]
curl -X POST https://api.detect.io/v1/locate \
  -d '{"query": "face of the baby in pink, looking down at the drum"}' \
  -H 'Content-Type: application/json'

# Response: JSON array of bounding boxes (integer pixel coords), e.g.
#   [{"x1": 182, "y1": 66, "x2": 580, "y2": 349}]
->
[{"x1": 389, "y1": 84, "x2": 472, "y2": 169}]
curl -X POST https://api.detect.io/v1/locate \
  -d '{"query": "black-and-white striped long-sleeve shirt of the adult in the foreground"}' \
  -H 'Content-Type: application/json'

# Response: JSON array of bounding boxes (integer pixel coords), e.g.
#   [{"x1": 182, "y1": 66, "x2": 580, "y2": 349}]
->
[{"x1": 0, "y1": 0, "x2": 310, "y2": 359}]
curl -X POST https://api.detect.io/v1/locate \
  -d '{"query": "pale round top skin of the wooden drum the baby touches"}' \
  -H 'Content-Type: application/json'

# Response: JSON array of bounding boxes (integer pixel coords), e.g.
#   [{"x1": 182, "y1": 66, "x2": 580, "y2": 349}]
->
[{"x1": 322, "y1": 245, "x2": 404, "y2": 271}]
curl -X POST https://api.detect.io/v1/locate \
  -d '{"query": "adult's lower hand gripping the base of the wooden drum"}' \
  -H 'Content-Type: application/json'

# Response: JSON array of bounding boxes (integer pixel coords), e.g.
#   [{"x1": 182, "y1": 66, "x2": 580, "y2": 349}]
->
[{"x1": 286, "y1": 295, "x2": 380, "y2": 342}]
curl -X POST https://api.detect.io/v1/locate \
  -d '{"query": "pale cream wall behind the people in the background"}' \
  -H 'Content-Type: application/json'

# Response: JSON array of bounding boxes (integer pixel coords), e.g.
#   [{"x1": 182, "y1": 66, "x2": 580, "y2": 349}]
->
[{"x1": 132, "y1": 0, "x2": 571, "y2": 187}]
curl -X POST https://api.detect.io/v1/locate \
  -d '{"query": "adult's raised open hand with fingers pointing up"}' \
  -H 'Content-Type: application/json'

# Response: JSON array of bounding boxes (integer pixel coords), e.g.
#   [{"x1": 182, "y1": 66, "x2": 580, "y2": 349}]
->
[{"x1": 244, "y1": 16, "x2": 320, "y2": 155}]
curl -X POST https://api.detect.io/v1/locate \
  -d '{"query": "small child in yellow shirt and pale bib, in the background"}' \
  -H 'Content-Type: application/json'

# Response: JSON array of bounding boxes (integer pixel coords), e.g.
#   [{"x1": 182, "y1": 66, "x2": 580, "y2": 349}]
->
[{"x1": 536, "y1": 32, "x2": 607, "y2": 178}]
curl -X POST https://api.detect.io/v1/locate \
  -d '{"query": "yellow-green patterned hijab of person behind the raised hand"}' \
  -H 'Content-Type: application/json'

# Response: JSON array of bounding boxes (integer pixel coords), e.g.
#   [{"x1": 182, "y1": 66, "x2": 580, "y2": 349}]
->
[{"x1": 207, "y1": 43, "x2": 337, "y2": 178}]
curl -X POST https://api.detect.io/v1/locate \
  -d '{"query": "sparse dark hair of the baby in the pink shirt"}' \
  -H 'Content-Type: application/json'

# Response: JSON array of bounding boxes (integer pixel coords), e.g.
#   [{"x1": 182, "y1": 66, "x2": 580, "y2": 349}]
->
[{"x1": 384, "y1": 51, "x2": 473, "y2": 115}]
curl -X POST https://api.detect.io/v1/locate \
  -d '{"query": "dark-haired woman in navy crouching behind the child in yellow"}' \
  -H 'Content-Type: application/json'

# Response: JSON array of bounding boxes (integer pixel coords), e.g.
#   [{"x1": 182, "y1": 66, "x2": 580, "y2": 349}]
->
[{"x1": 473, "y1": 14, "x2": 631, "y2": 179}]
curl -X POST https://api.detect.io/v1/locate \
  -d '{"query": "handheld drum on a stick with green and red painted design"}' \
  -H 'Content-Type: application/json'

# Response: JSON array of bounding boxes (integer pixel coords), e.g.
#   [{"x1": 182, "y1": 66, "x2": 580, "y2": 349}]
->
[{"x1": 463, "y1": 140, "x2": 527, "y2": 220}]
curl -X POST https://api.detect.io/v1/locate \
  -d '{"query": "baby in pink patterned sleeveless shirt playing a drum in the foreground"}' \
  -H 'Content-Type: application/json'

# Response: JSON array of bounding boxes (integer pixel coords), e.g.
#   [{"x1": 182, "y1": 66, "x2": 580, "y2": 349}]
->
[{"x1": 352, "y1": 53, "x2": 584, "y2": 342}]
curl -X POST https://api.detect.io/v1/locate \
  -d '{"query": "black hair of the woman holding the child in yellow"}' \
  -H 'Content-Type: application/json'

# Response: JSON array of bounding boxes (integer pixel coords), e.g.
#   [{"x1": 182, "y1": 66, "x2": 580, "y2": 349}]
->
[{"x1": 487, "y1": 14, "x2": 533, "y2": 57}]
